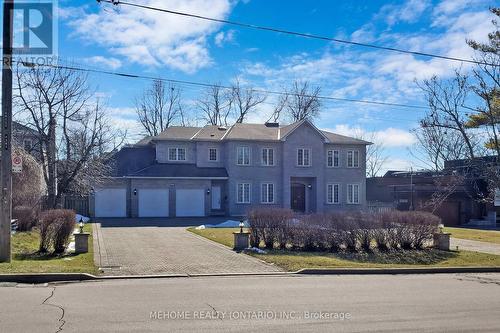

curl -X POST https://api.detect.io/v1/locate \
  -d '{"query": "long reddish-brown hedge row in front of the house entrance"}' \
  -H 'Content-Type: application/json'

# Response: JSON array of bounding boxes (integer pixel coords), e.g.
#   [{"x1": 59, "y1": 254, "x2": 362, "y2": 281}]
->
[{"x1": 248, "y1": 207, "x2": 441, "y2": 252}]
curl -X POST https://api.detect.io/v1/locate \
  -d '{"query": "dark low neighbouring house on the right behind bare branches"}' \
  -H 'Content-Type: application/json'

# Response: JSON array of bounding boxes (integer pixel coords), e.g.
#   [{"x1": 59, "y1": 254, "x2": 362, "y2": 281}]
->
[{"x1": 366, "y1": 157, "x2": 500, "y2": 226}]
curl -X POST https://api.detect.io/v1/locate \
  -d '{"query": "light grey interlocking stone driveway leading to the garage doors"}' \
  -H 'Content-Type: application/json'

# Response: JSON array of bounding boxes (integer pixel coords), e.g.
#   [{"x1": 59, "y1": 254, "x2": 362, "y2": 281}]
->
[{"x1": 94, "y1": 220, "x2": 280, "y2": 275}]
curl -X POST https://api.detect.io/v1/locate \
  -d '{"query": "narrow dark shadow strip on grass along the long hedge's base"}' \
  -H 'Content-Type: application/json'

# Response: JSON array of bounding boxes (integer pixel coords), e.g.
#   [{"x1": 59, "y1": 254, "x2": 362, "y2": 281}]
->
[{"x1": 268, "y1": 249, "x2": 458, "y2": 265}]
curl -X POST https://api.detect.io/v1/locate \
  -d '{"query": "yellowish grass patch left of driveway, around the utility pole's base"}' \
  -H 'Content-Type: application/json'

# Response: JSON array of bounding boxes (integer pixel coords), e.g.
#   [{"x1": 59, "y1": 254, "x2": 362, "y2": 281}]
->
[{"x1": 0, "y1": 224, "x2": 98, "y2": 274}]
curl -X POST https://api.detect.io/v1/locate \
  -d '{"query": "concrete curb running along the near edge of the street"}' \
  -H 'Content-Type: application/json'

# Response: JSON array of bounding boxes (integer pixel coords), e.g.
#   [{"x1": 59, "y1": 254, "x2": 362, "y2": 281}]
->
[{"x1": 0, "y1": 267, "x2": 500, "y2": 284}]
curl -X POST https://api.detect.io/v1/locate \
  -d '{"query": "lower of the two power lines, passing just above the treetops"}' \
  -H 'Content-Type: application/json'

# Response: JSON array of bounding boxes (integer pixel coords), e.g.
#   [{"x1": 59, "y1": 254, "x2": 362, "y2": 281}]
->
[{"x1": 13, "y1": 60, "x2": 428, "y2": 110}]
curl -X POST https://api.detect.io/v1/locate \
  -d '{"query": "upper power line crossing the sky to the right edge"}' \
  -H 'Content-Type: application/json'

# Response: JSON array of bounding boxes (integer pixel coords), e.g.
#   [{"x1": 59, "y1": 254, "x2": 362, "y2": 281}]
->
[{"x1": 97, "y1": 0, "x2": 500, "y2": 67}]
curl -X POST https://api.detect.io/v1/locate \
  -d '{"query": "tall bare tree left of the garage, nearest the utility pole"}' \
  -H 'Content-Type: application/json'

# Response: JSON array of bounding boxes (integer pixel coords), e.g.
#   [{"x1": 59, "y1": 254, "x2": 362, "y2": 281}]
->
[{"x1": 14, "y1": 67, "x2": 124, "y2": 207}]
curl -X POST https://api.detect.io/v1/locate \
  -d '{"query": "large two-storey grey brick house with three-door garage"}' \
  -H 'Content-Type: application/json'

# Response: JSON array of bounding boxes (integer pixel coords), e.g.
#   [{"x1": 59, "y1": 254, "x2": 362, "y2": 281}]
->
[{"x1": 91, "y1": 120, "x2": 370, "y2": 217}]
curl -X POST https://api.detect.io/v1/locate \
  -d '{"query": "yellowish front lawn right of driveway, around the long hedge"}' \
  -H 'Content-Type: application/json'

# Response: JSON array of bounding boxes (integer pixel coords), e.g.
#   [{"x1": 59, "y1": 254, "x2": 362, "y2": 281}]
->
[{"x1": 188, "y1": 228, "x2": 500, "y2": 271}]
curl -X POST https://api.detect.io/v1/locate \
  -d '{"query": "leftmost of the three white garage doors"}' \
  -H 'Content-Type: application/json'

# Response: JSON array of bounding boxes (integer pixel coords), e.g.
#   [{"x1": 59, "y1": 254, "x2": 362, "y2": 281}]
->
[{"x1": 95, "y1": 188, "x2": 127, "y2": 217}]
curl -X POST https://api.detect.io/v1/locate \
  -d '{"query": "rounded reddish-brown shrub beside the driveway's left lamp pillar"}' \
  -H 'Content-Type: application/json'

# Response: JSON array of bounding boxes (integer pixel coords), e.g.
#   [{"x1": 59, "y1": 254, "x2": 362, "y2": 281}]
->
[{"x1": 39, "y1": 209, "x2": 75, "y2": 253}]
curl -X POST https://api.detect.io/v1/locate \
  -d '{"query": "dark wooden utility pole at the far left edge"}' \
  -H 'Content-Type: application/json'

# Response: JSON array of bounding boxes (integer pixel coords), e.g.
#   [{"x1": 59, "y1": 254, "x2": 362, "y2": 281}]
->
[{"x1": 0, "y1": 0, "x2": 14, "y2": 262}]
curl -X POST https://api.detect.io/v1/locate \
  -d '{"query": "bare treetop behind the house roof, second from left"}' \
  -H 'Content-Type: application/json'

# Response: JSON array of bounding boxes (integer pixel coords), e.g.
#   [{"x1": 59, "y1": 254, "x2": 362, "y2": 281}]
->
[{"x1": 197, "y1": 84, "x2": 233, "y2": 126}]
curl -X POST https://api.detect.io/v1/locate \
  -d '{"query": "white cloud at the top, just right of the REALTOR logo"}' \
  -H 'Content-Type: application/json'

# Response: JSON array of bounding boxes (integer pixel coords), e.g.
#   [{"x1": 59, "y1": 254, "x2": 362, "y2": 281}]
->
[{"x1": 68, "y1": 0, "x2": 232, "y2": 73}]
